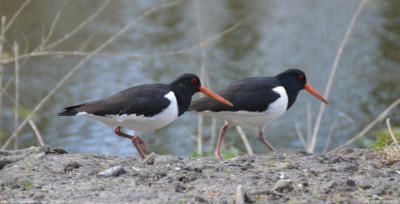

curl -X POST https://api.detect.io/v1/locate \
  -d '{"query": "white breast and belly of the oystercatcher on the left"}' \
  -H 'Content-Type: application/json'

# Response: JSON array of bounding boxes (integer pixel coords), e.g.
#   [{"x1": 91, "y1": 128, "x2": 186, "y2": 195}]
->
[{"x1": 78, "y1": 91, "x2": 178, "y2": 134}]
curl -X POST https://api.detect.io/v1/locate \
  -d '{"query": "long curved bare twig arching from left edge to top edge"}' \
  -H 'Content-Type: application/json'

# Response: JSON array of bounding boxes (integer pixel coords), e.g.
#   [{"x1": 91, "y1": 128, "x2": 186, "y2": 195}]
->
[{"x1": 1, "y1": 0, "x2": 182, "y2": 150}]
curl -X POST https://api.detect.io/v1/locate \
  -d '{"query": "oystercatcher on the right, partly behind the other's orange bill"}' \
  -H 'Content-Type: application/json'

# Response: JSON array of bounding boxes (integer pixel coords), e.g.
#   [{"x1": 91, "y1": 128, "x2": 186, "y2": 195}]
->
[{"x1": 189, "y1": 69, "x2": 328, "y2": 159}]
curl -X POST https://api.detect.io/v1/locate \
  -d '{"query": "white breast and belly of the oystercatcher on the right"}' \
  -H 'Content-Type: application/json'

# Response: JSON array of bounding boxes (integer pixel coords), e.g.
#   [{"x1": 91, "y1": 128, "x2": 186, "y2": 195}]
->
[{"x1": 201, "y1": 86, "x2": 288, "y2": 128}]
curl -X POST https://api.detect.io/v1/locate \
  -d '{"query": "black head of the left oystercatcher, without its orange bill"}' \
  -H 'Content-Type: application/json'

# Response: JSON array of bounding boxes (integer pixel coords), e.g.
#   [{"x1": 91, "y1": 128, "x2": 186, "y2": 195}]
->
[{"x1": 169, "y1": 73, "x2": 201, "y2": 96}]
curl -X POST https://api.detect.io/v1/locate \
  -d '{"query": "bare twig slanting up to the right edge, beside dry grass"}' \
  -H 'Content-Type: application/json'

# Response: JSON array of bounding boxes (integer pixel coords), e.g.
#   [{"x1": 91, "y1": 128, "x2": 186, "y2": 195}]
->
[{"x1": 330, "y1": 98, "x2": 400, "y2": 152}]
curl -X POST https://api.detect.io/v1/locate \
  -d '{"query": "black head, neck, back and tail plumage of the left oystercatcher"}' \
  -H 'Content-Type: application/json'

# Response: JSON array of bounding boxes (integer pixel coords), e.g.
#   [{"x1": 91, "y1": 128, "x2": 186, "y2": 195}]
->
[{"x1": 58, "y1": 74, "x2": 201, "y2": 117}]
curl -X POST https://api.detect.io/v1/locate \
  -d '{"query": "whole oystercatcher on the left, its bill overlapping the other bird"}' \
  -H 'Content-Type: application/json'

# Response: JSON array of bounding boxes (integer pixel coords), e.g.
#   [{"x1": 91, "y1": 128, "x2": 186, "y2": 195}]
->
[{"x1": 58, "y1": 73, "x2": 232, "y2": 159}]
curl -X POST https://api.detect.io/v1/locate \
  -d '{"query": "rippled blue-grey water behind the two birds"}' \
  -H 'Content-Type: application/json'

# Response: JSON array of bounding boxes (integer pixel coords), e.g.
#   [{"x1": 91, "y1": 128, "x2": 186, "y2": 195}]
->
[{"x1": 0, "y1": 0, "x2": 400, "y2": 157}]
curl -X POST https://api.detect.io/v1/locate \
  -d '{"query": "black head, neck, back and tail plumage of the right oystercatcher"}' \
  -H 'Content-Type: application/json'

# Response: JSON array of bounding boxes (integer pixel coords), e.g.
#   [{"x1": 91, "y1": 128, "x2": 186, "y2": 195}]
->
[{"x1": 189, "y1": 69, "x2": 306, "y2": 112}]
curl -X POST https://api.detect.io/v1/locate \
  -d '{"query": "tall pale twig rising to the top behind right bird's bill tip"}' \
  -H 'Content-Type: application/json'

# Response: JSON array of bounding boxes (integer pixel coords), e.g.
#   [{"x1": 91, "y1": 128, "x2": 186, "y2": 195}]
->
[{"x1": 308, "y1": 0, "x2": 367, "y2": 152}]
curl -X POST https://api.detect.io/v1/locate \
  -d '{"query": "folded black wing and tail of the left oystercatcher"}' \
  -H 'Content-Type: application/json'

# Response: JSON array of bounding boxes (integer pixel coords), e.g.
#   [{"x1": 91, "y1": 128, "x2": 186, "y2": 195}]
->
[{"x1": 58, "y1": 84, "x2": 171, "y2": 117}]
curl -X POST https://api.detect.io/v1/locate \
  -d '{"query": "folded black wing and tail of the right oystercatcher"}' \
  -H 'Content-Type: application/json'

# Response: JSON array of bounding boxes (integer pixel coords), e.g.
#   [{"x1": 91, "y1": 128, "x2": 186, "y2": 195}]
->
[{"x1": 189, "y1": 77, "x2": 282, "y2": 112}]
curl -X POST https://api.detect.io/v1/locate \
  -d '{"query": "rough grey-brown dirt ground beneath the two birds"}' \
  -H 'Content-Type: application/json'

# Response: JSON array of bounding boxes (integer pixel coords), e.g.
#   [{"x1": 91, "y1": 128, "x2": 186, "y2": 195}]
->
[{"x1": 0, "y1": 146, "x2": 400, "y2": 203}]
